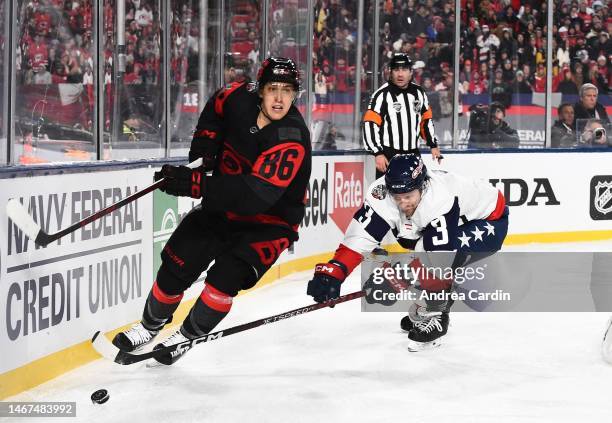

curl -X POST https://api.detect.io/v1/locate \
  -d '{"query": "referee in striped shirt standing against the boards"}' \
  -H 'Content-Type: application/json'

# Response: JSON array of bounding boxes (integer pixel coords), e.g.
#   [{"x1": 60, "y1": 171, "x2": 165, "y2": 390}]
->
[{"x1": 363, "y1": 53, "x2": 442, "y2": 178}]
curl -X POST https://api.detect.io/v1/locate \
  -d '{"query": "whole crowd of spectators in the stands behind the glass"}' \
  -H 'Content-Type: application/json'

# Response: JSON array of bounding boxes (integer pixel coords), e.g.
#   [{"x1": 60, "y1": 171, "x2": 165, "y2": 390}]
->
[{"x1": 16, "y1": 0, "x2": 612, "y2": 144}]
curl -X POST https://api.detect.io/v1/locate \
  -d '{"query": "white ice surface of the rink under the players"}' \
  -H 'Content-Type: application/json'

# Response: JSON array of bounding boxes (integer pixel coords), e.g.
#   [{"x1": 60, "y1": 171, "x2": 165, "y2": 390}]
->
[{"x1": 10, "y1": 242, "x2": 612, "y2": 423}]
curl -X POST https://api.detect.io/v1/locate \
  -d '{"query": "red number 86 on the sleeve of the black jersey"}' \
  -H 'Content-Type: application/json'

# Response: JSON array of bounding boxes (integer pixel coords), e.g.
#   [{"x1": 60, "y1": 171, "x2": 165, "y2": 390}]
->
[{"x1": 253, "y1": 143, "x2": 305, "y2": 187}]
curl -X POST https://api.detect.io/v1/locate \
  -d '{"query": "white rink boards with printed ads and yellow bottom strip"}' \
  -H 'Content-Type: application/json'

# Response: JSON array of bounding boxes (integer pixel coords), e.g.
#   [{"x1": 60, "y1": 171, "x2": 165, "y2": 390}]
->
[{"x1": 0, "y1": 151, "x2": 612, "y2": 399}]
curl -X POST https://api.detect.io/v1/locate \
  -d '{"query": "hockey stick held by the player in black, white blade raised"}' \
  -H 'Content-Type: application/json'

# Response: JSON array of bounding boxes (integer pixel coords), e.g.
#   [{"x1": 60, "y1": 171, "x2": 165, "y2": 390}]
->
[{"x1": 6, "y1": 159, "x2": 202, "y2": 247}]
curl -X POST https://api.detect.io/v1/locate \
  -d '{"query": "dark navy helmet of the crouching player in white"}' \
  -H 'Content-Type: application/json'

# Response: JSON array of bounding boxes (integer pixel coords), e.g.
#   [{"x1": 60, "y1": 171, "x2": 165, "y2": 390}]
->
[{"x1": 385, "y1": 153, "x2": 428, "y2": 194}]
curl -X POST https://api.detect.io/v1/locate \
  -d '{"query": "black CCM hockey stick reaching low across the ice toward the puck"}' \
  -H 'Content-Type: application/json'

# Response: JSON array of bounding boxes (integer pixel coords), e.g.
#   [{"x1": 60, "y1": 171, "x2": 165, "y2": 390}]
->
[{"x1": 91, "y1": 291, "x2": 366, "y2": 365}]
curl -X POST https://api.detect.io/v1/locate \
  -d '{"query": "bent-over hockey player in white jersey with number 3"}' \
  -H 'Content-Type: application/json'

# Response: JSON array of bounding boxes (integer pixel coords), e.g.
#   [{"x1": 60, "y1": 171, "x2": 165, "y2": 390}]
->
[{"x1": 307, "y1": 154, "x2": 508, "y2": 351}]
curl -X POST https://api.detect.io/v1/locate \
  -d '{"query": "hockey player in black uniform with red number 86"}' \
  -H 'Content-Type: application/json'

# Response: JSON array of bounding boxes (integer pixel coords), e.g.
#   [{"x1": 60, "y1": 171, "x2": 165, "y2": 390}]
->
[{"x1": 113, "y1": 57, "x2": 311, "y2": 364}]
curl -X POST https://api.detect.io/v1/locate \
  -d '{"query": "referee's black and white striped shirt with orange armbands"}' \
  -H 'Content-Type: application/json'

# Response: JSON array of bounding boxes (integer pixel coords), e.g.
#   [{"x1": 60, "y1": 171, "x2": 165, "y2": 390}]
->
[{"x1": 363, "y1": 82, "x2": 438, "y2": 154}]
